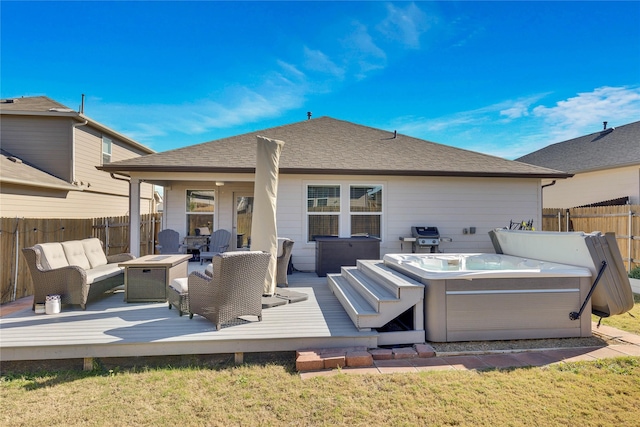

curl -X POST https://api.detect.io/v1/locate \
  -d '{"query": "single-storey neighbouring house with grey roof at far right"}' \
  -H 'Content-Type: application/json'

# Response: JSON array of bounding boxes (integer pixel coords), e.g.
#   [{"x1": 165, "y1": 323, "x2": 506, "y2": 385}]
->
[{"x1": 516, "y1": 122, "x2": 640, "y2": 208}]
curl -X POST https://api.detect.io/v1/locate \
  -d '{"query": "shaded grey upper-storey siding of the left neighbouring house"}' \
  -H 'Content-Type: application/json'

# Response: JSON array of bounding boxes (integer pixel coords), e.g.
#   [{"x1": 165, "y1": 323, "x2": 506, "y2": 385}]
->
[{"x1": 0, "y1": 115, "x2": 74, "y2": 182}]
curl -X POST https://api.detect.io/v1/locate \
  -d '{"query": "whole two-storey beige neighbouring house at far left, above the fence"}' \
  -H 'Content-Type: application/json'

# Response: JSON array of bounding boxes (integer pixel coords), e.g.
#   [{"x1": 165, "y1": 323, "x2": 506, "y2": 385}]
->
[{"x1": 0, "y1": 96, "x2": 157, "y2": 218}]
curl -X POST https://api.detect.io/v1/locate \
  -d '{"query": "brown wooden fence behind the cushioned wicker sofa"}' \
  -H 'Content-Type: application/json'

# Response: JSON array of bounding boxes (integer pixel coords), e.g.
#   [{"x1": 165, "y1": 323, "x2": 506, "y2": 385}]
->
[{"x1": 0, "y1": 214, "x2": 162, "y2": 303}]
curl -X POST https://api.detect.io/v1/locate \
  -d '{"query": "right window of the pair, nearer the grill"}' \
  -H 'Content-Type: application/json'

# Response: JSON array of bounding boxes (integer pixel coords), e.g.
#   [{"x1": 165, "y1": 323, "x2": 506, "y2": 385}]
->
[{"x1": 349, "y1": 185, "x2": 382, "y2": 238}]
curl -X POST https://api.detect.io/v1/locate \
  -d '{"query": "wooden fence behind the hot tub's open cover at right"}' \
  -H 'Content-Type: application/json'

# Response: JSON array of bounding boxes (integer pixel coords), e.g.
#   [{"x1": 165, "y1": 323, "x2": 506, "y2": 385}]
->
[{"x1": 542, "y1": 205, "x2": 640, "y2": 271}]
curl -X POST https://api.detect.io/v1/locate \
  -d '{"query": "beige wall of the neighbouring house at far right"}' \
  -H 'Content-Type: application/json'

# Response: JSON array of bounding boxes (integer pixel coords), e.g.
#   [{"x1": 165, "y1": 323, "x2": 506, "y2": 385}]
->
[{"x1": 542, "y1": 165, "x2": 640, "y2": 208}]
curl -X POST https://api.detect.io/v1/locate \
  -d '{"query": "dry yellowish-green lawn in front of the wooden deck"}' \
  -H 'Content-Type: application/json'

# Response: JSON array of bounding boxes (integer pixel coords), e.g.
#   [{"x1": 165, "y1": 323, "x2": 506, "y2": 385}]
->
[{"x1": 0, "y1": 357, "x2": 640, "y2": 427}]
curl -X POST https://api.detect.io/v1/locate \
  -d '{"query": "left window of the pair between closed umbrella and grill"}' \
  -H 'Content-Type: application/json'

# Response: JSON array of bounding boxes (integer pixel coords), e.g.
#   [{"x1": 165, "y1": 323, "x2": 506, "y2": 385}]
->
[{"x1": 307, "y1": 185, "x2": 340, "y2": 242}]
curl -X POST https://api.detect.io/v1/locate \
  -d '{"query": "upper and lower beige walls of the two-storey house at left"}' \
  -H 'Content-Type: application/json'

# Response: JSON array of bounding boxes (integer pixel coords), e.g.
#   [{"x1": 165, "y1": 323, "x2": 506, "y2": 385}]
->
[{"x1": 0, "y1": 115, "x2": 155, "y2": 218}]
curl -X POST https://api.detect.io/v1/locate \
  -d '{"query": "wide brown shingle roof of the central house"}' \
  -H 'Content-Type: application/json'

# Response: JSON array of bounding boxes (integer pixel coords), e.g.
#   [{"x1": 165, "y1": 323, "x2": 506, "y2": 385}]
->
[{"x1": 101, "y1": 117, "x2": 570, "y2": 178}]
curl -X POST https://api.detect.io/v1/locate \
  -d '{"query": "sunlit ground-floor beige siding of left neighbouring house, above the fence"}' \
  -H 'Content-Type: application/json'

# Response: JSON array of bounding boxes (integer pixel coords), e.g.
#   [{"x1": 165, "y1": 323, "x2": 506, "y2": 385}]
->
[{"x1": 0, "y1": 184, "x2": 152, "y2": 218}]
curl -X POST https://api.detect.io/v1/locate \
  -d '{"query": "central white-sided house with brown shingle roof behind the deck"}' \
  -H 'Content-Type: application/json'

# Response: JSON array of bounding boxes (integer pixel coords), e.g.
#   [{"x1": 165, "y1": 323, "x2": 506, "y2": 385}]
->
[{"x1": 100, "y1": 117, "x2": 571, "y2": 271}]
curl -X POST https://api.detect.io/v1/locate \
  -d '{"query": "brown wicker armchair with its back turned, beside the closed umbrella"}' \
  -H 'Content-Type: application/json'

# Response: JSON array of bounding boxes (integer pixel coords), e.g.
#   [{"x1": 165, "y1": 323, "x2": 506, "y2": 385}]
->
[{"x1": 188, "y1": 251, "x2": 271, "y2": 330}]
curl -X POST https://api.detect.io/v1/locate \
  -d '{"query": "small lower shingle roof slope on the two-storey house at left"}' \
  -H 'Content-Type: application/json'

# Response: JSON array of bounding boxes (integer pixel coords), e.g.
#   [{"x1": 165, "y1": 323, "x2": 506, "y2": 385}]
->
[{"x1": 0, "y1": 149, "x2": 81, "y2": 191}]
